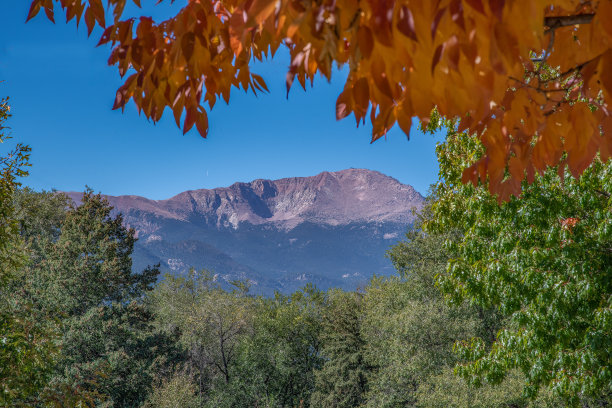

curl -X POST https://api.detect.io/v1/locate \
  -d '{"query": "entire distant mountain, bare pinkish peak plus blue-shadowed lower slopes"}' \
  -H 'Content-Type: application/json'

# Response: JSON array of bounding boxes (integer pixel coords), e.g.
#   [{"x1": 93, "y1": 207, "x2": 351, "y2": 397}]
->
[{"x1": 68, "y1": 169, "x2": 424, "y2": 294}]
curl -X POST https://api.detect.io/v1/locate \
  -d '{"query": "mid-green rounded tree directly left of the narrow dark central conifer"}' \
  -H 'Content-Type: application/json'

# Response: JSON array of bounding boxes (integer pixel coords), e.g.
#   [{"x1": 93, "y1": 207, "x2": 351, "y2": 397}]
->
[{"x1": 228, "y1": 285, "x2": 324, "y2": 407}]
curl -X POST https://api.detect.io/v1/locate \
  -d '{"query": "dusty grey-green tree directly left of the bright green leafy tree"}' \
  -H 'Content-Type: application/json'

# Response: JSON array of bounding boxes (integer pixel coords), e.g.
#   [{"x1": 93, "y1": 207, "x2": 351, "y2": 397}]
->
[{"x1": 362, "y1": 223, "x2": 510, "y2": 407}]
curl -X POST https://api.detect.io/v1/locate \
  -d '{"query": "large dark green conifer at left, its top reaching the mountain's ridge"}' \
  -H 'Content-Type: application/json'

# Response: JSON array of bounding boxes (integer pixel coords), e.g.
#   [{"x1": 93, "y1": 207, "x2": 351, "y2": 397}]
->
[{"x1": 11, "y1": 190, "x2": 177, "y2": 407}]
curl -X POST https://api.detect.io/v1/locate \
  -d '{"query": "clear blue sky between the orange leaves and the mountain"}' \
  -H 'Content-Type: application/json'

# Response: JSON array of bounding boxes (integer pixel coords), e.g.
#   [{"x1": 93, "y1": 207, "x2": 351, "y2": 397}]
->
[{"x1": 0, "y1": 0, "x2": 440, "y2": 199}]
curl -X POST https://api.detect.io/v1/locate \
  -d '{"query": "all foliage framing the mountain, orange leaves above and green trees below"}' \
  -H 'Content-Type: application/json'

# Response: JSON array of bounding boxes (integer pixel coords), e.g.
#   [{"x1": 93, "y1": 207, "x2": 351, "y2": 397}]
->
[{"x1": 0, "y1": 0, "x2": 612, "y2": 408}]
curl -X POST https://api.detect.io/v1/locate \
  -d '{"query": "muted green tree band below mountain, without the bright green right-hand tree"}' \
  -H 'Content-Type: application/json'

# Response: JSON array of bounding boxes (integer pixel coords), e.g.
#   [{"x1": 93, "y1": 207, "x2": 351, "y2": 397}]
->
[{"x1": 3, "y1": 189, "x2": 558, "y2": 407}]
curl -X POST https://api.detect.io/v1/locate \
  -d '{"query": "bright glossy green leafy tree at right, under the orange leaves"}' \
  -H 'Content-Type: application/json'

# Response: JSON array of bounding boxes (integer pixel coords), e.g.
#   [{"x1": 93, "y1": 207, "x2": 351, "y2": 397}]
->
[{"x1": 424, "y1": 123, "x2": 612, "y2": 406}]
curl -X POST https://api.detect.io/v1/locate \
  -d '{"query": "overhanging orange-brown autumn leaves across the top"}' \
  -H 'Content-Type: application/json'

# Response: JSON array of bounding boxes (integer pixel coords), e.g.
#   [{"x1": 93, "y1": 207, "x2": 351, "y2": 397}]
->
[{"x1": 28, "y1": 0, "x2": 612, "y2": 199}]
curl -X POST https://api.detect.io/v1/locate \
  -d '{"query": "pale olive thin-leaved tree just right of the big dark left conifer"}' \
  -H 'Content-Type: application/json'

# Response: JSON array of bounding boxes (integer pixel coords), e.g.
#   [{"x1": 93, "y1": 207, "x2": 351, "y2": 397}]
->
[{"x1": 151, "y1": 270, "x2": 253, "y2": 406}]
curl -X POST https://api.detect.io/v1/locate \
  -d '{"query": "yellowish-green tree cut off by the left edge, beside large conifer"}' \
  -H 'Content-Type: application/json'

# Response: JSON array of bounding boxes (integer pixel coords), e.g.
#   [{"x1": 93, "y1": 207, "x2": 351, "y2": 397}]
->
[{"x1": 0, "y1": 99, "x2": 57, "y2": 406}]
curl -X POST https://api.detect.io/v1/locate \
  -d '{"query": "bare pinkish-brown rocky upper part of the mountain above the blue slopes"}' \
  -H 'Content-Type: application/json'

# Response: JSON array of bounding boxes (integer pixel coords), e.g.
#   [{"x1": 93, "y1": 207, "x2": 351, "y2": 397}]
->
[{"x1": 67, "y1": 169, "x2": 423, "y2": 232}]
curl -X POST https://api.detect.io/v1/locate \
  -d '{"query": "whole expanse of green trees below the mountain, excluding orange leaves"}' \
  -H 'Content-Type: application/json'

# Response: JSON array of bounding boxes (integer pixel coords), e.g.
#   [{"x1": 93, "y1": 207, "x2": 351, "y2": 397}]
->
[{"x1": 0, "y1": 95, "x2": 612, "y2": 407}]
